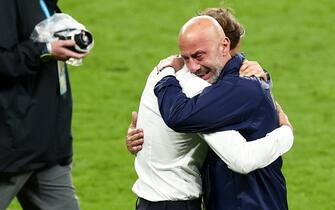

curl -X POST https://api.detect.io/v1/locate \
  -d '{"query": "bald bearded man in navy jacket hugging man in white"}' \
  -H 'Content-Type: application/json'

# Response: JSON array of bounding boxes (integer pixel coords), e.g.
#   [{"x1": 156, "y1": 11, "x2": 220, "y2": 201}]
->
[{"x1": 154, "y1": 16, "x2": 288, "y2": 210}]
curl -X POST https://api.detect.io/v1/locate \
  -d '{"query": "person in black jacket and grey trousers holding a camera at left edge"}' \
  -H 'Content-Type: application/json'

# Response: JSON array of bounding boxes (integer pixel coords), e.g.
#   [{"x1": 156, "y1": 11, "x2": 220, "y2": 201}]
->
[{"x1": 0, "y1": 0, "x2": 87, "y2": 210}]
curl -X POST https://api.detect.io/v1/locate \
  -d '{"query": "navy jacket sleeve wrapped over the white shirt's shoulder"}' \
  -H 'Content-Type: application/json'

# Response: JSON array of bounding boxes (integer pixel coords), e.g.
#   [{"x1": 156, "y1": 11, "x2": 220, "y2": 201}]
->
[{"x1": 154, "y1": 76, "x2": 261, "y2": 133}]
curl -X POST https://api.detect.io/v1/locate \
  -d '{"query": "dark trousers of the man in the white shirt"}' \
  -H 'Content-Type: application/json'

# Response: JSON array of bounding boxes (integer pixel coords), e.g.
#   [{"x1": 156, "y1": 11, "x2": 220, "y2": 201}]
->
[{"x1": 136, "y1": 198, "x2": 201, "y2": 210}]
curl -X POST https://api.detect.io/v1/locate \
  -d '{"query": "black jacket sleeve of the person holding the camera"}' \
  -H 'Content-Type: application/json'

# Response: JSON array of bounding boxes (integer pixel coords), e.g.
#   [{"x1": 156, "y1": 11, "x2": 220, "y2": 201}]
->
[{"x1": 0, "y1": 1, "x2": 46, "y2": 79}]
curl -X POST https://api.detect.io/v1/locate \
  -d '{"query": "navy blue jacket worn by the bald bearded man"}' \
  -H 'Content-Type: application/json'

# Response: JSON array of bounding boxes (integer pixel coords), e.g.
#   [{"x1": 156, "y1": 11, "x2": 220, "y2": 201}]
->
[{"x1": 154, "y1": 55, "x2": 288, "y2": 210}]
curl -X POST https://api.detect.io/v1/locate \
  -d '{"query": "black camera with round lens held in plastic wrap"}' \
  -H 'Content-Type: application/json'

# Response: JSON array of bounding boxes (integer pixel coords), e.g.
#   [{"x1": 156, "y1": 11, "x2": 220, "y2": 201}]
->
[{"x1": 54, "y1": 28, "x2": 94, "y2": 53}]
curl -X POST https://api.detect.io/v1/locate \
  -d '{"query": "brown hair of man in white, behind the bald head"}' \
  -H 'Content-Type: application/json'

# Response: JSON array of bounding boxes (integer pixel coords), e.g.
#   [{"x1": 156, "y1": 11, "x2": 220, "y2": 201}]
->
[{"x1": 198, "y1": 8, "x2": 245, "y2": 49}]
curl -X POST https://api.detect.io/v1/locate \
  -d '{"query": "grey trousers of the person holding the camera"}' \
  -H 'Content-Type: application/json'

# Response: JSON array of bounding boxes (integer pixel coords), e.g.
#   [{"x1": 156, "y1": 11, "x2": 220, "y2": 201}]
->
[{"x1": 0, "y1": 165, "x2": 79, "y2": 210}]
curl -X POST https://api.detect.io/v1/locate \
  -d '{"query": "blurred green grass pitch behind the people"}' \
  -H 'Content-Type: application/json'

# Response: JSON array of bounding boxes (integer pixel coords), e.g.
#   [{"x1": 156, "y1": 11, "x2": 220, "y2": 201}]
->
[{"x1": 9, "y1": 0, "x2": 335, "y2": 210}]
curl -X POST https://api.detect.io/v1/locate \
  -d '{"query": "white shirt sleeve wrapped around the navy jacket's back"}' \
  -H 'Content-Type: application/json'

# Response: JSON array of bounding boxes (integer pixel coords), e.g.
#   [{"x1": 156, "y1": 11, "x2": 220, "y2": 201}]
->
[{"x1": 201, "y1": 126, "x2": 294, "y2": 174}]
